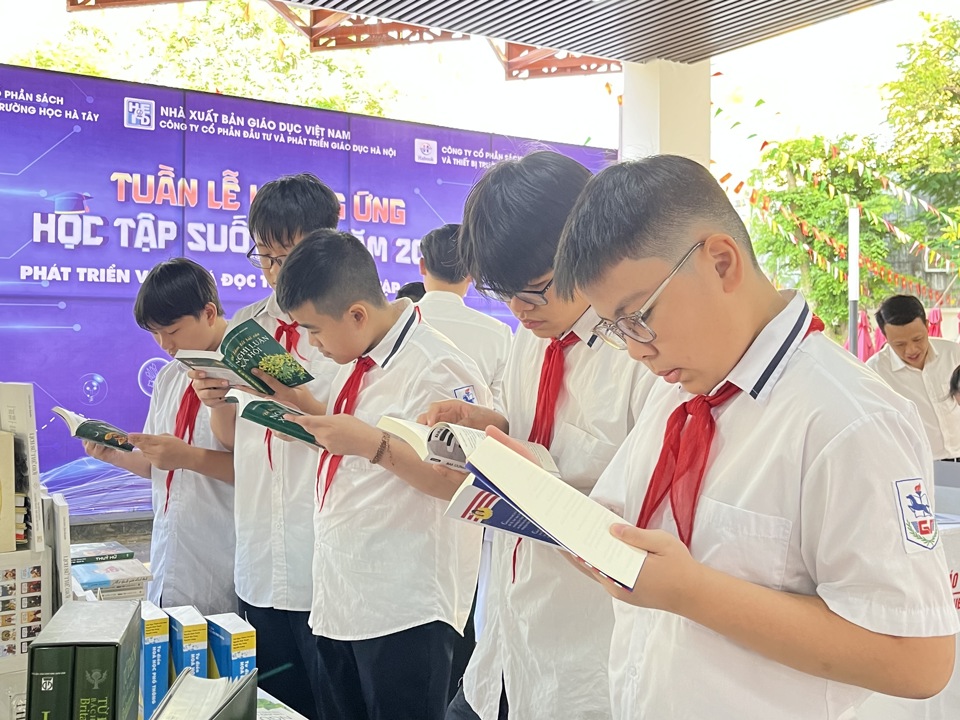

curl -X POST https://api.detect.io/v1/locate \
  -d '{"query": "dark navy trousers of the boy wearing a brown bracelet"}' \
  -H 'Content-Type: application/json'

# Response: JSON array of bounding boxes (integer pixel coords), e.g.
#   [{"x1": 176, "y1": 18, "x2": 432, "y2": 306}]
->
[{"x1": 316, "y1": 622, "x2": 459, "y2": 720}]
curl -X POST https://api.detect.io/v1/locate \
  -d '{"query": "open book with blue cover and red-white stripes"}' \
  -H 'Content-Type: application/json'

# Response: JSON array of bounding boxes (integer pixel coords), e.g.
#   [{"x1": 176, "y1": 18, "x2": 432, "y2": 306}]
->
[{"x1": 444, "y1": 438, "x2": 647, "y2": 589}]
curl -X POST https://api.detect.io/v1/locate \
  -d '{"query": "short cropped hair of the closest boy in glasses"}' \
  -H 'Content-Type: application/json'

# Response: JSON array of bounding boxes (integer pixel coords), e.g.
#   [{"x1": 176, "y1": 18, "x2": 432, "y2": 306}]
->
[{"x1": 555, "y1": 155, "x2": 760, "y2": 298}]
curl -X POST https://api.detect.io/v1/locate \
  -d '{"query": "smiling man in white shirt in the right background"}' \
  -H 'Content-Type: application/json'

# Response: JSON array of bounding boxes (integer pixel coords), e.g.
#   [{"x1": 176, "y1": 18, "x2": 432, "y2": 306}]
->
[{"x1": 867, "y1": 295, "x2": 960, "y2": 460}]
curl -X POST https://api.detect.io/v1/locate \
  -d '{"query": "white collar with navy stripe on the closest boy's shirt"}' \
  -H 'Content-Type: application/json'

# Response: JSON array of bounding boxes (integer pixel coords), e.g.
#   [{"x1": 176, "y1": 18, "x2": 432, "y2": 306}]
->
[{"x1": 720, "y1": 290, "x2": 811, "y2": 403}]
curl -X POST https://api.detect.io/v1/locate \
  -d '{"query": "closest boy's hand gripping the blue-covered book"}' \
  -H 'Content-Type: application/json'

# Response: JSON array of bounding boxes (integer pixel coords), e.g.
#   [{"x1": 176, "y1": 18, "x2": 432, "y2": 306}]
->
[{"x1": 568, "y1": 523, "x2": 704, "y2": 615}]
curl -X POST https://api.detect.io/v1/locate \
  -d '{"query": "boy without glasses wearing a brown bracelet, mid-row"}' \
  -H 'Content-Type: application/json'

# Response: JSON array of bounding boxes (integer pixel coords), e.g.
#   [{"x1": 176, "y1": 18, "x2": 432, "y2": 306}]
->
[{"x1": 277, "y1": 230, "x2": 490, "y2": 720}]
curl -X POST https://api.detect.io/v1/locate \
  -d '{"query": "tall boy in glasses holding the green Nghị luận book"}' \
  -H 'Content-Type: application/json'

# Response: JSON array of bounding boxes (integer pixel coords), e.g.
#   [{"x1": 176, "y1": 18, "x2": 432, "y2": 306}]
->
[{"x1": 191, "y1": 173, "x2": 340, "y2": 718}]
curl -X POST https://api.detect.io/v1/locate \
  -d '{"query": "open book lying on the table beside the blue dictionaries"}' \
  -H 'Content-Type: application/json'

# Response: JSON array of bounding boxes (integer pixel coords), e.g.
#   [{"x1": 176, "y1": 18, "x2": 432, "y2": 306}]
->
[{"x1": 153, "y1": 668, "x2": 257, "y2": 720}]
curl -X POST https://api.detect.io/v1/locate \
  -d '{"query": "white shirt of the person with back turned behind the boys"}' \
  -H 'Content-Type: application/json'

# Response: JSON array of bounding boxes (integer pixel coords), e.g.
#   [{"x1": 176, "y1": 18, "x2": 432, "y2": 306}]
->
[{"x1": 417, "y1": 290, "x2": 513, "y2": 409}]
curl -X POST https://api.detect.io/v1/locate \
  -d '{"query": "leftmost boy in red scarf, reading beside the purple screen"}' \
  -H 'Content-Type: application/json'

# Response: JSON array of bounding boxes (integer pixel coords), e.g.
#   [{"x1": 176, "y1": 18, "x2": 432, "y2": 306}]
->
[{"x1": 84, "y1": 258, "x2": 237, "y2": 613}]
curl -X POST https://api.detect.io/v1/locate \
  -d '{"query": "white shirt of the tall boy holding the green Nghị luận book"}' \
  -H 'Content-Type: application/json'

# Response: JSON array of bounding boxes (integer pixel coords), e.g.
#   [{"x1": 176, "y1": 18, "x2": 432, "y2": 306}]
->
[{"x1": 231, "y1": 294, "x2": 338, "y2": 611}]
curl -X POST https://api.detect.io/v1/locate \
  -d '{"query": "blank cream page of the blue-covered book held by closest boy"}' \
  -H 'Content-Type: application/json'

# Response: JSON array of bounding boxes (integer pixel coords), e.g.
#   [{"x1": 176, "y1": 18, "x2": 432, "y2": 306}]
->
[{"x1": 468, "y1": 438, "x2": 646, "y2": 588}]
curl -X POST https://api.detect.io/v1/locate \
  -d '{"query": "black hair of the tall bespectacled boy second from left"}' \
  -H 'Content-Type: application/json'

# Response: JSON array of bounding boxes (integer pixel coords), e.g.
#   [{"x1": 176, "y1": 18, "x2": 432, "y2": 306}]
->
[{"x1": 249, "y1": 173, "x2": 340, "y2": 248}]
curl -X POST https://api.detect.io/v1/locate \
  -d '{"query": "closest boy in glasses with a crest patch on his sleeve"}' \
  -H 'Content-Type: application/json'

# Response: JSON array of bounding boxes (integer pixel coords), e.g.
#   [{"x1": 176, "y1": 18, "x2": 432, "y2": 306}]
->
[{"x1": 556, "y1": 155, "x2": 960, "y2": 720}]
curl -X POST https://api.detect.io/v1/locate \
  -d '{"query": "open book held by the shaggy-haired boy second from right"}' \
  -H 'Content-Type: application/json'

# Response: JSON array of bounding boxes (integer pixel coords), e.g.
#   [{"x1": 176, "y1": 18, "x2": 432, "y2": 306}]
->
[{"x1": 377, "y1": 415, "x2": 560, "y2": 475}]
